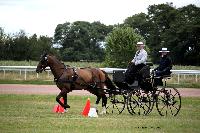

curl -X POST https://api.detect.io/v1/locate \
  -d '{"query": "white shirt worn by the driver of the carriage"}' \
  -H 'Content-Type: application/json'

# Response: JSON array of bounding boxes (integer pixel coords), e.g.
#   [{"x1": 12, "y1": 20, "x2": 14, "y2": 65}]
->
[{"x1": 131, "y1": 49, "x2": 147, "y2": 65}]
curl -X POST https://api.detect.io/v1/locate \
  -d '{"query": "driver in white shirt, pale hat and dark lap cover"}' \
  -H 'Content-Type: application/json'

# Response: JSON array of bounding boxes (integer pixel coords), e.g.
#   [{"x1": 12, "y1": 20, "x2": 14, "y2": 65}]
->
[{"x1": 125, "y1": 42, "x2": 147, "y2": 84}]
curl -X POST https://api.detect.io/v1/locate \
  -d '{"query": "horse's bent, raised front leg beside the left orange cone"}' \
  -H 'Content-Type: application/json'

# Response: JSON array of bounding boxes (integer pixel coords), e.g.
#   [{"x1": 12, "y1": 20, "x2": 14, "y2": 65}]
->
[{"x1": 56, "y1": 88, "x2": 70, "y2": 109}]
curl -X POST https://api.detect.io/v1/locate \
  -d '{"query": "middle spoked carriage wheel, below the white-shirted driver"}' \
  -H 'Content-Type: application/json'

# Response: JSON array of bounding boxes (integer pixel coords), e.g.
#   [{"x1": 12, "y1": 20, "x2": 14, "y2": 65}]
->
[{"x1": 127, "y1": 89, "x2": 151, "y2": 115}]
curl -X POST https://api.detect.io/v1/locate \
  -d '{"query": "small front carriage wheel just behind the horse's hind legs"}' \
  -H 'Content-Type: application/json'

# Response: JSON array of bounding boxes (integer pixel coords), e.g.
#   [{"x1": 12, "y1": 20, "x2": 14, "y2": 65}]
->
[{"x1": 106, "y1": 94, "x2": 126, "y2": 114}]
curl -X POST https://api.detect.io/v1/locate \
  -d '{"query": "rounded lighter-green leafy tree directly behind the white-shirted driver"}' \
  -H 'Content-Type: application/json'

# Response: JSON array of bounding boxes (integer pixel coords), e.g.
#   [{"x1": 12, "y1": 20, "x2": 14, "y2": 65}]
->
[{"x1": 105, "y1": 26, "x2": 145, "y2": 68}]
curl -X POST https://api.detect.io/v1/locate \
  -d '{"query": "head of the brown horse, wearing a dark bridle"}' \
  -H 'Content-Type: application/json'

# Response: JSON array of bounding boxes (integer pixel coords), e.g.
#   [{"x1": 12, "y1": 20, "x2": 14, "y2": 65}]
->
[{"x1": 36, "y1": 53, "x2": 48, "y2": 73}]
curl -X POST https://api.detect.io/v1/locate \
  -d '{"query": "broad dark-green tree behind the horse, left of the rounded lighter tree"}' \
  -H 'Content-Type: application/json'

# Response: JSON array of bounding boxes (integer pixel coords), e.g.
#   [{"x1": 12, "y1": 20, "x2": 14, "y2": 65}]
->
[{"x1": 54, "y1": 21, "x2": 111, "y2": 61}]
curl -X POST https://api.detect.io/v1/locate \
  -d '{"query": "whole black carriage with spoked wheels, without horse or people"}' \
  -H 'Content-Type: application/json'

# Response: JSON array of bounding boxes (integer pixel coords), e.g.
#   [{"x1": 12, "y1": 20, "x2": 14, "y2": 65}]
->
[{"x1": 104, "y1": 63, "x2": 181, "y2": 116}]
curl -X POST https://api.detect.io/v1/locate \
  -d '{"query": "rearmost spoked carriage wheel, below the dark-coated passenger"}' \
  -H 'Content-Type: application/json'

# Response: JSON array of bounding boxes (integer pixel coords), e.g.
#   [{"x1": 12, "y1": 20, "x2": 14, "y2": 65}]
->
[{"x1": 156, "y1": 88, "x2": 181, "y2": 116}]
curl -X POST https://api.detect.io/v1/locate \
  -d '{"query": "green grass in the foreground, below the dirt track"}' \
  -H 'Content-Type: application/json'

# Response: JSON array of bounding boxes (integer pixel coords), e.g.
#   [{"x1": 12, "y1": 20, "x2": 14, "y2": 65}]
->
[{"x1": 0, "y1": 95, "x2": 200, "y2": 133}]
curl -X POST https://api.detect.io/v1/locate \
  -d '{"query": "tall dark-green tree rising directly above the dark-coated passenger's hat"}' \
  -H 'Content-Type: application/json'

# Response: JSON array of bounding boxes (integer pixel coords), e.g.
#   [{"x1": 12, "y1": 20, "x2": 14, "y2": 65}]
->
[{"x1": 146, "y1": 3, "x2": 177, "y2": 62}]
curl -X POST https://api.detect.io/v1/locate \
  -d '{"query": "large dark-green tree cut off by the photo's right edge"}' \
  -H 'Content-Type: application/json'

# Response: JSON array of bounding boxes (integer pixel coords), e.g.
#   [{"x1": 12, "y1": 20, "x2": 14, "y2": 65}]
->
[{"x1": 163, "y1": 5, "x2": 200, "y2": 65}]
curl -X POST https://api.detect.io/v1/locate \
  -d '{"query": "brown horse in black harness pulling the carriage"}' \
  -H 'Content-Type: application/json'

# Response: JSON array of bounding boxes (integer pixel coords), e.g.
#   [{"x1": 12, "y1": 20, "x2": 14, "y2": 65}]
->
[{"x1": 36, "y1": 53, "x2": 116, "y2": 114}]
